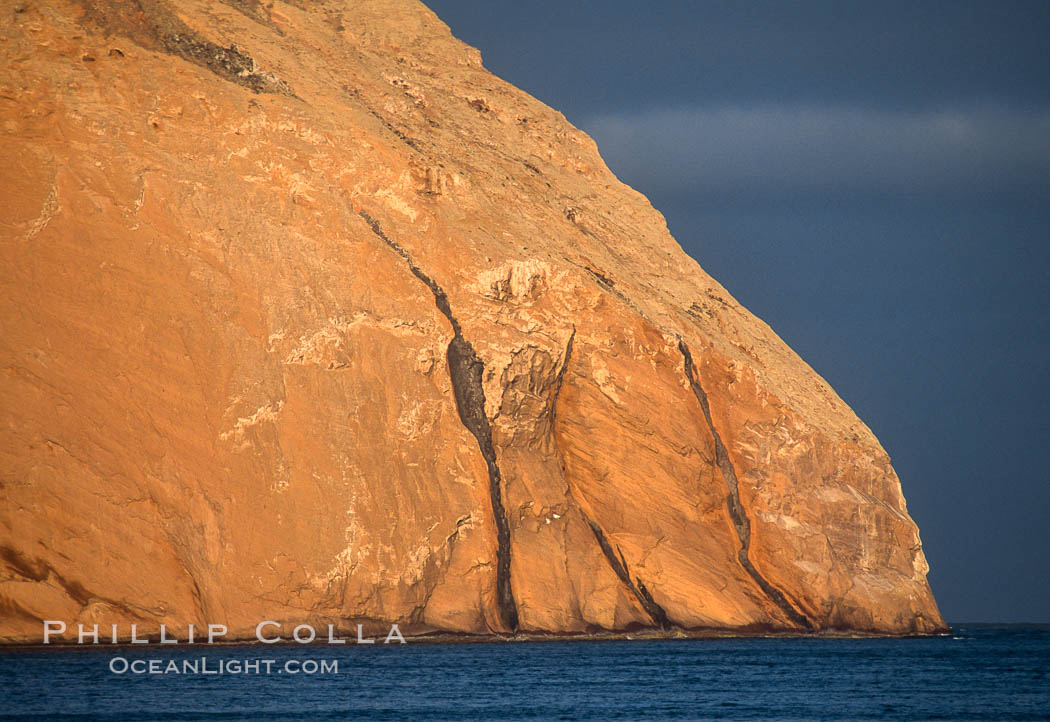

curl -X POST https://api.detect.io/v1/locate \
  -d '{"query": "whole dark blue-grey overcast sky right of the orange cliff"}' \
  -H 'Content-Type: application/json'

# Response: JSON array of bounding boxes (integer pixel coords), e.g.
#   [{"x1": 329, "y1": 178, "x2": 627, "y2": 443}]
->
[{"x1": 427, "y1": 0, "x2": 1050, "y2": 622}]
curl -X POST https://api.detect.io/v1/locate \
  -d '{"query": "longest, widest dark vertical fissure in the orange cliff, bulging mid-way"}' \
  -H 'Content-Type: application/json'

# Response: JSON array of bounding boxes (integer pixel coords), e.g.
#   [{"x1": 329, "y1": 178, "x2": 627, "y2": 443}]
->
[{"x1": 359, "y1": 210, "x2": 518, "y2": 632}]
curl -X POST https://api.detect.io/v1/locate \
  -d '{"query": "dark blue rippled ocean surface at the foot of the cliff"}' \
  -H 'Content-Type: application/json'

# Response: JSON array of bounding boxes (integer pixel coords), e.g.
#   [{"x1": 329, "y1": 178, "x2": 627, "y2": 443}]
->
[{"x1": 0, "y1": 625, "x2": 1050, "y2": 720}]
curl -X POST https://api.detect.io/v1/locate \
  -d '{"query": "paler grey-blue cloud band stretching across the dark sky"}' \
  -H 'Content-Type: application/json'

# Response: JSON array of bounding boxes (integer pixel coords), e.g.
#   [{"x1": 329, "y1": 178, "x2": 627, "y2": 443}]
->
[{"x1": 582, "y1": 105, "x2": 1050, "y2": 193}]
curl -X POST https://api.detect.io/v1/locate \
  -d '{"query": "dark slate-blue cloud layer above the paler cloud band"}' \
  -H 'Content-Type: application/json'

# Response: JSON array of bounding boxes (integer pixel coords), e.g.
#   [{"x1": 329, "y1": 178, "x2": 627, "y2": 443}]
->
[{"x1": 427, "y1": 0, "x2": 1050, "y2": 115}]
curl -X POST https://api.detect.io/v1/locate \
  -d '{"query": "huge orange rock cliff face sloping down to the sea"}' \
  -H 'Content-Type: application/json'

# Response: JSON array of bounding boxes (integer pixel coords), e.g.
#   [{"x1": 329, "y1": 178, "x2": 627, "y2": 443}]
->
[{"x1": 0, "y1": 0, "x2": 944, "y2": 641}]
